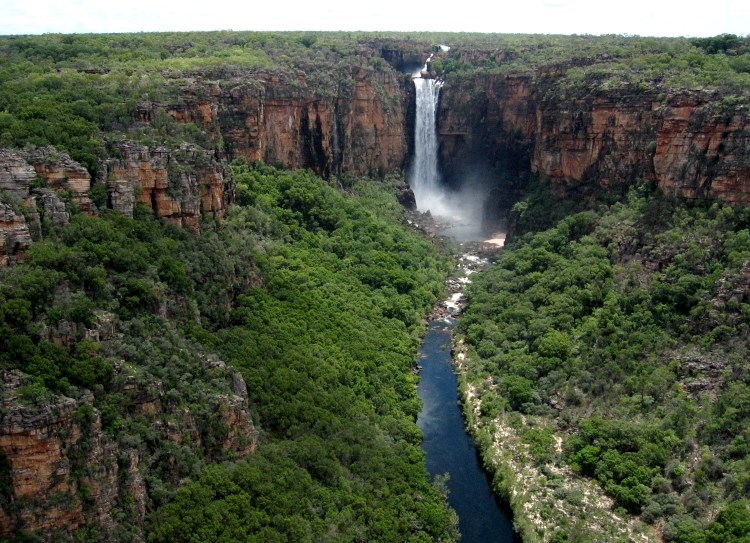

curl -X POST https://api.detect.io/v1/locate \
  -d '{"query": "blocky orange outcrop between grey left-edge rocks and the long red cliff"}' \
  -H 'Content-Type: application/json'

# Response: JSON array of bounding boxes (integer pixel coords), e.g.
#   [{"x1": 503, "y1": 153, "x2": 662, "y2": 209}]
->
[{"x1": 98, "y1": 140, "x2": 234, "y2": 231}]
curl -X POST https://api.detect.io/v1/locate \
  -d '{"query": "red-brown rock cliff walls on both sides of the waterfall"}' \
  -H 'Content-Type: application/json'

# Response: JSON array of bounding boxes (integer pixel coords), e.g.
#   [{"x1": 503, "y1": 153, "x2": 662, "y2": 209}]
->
[{"x1": 0, "y1": 54, "x2": 750, "y2": 258}]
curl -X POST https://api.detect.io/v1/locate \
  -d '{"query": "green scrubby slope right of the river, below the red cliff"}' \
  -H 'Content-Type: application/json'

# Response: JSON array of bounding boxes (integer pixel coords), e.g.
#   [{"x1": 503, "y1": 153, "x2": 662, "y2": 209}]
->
[{"x1": 459, "y1": 182, "x2": 750, "y2": 543}]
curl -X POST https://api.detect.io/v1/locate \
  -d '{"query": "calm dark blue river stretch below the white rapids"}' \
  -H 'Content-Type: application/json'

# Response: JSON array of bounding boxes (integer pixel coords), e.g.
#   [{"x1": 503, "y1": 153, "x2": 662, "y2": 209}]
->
[{"x1": 417, "y1": 318, "x2": 520, "y2": 543}]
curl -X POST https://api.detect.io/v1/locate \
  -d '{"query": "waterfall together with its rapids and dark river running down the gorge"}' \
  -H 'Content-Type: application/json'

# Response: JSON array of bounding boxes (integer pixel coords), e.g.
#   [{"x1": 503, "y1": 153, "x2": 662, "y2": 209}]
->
[{"x1": 409, "y1": 51, "x2": 518, "y2": 543}]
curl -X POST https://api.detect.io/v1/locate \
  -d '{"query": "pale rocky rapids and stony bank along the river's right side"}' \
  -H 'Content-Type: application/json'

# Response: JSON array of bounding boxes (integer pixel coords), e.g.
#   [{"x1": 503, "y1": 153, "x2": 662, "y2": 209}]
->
[{"x1": 450, "y1": 241, "x2": 660, "y2": 543}]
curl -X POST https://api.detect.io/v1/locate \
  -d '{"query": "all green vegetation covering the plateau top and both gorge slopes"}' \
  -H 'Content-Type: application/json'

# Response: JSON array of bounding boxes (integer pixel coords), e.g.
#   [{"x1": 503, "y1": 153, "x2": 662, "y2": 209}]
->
[{"x1": 0, "y1": 32, "x2": 750, "y2": 543}]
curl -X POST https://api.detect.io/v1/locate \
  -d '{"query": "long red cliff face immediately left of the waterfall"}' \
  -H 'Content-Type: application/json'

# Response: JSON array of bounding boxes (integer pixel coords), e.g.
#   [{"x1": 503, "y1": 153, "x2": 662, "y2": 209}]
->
[{"x1": 145, "y1": 68, "x2": 412, "y2": 177}]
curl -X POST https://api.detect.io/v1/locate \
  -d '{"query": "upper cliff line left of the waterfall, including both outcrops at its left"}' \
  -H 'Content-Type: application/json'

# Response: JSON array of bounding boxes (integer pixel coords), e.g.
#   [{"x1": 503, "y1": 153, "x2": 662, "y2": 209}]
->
[{"x1": 0, "y1": 67, "x2": 413, "y2": 265}]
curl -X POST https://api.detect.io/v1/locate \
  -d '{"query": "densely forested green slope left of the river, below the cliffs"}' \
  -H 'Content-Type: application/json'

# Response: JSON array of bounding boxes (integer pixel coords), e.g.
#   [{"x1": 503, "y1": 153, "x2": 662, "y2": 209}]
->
[{"x1": 0, "y1": 161, "x2": 455, "y2": 542}]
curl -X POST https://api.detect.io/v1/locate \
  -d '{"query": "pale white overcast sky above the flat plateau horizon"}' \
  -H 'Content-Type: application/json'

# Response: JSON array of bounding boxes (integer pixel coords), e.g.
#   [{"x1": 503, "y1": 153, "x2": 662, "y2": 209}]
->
[{"x1": 0, "y1": 0, "x2": 750, "y2": 36}]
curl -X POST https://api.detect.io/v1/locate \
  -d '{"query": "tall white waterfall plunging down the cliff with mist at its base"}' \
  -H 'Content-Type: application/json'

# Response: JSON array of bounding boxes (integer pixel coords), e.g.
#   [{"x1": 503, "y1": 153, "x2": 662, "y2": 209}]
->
[{"x1": 409, "y1": 74, "x2": 500, "y2": 241}]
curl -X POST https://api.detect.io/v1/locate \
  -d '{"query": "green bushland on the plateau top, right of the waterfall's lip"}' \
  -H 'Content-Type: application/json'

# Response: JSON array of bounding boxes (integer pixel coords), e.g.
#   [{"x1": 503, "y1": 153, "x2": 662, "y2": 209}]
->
[{"x1": 433, "y1": 34, "x2": 750, "y2": 96}]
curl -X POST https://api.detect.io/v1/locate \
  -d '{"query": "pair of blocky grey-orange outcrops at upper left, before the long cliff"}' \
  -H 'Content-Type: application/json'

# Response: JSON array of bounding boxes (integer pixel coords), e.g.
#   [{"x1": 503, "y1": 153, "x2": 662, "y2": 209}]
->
[{"x1": 0, "y1": 144, "x2": 234, "y2": 268}]
